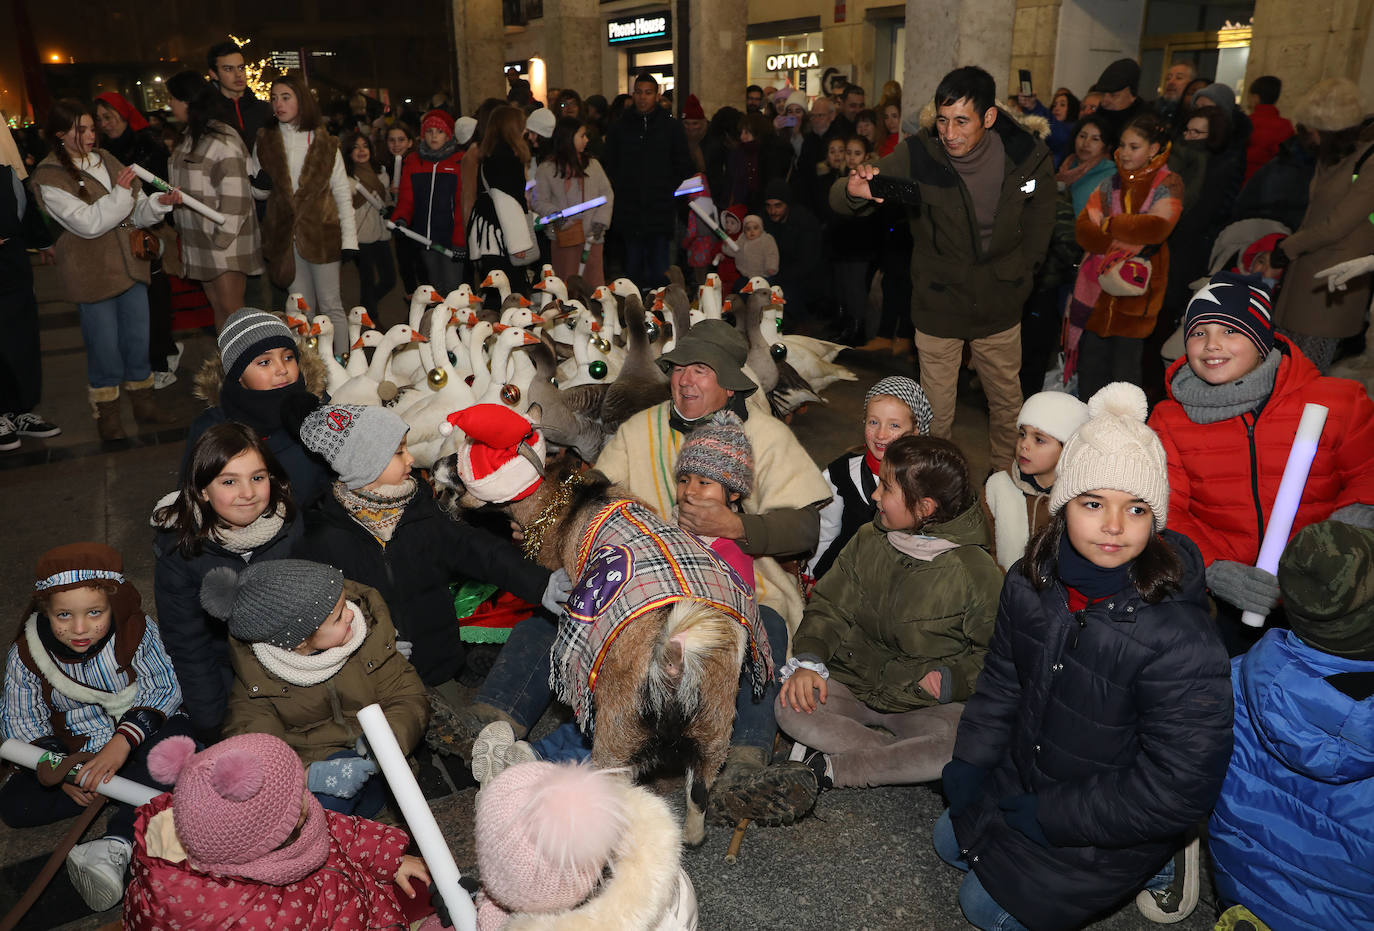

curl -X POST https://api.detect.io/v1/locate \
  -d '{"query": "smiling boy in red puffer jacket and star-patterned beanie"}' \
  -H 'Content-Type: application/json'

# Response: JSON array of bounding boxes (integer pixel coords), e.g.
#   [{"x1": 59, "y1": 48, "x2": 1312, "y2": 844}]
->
[{"x1": 1150, "y1": 272, "x2": 1374, "y2": 655}]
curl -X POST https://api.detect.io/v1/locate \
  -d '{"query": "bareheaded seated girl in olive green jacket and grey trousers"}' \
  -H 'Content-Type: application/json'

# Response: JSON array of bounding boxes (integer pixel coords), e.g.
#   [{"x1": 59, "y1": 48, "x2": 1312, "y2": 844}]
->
[{"x1": 775, "y1": 437, "x2": 1002, "y2": 788}]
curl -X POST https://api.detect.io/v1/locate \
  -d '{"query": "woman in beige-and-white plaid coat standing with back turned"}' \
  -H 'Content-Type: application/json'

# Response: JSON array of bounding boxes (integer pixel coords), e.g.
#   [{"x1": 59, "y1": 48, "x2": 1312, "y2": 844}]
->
[{"x1": 165, "y1": 71, "x2": 262, "y2": 330}]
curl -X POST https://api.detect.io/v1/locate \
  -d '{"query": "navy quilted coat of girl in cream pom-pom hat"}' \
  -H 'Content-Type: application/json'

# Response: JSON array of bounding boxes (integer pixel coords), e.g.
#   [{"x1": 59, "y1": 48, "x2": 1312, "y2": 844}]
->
[{"x1": 954, "y1": 530, "x2": 1232, "y2": 931}]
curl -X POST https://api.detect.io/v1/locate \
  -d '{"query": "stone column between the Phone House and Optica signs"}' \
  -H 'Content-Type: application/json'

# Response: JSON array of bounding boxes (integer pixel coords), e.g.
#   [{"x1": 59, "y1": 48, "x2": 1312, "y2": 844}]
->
[{"x1": 684, "y1": 0, "x2": 749, "y2": 114}]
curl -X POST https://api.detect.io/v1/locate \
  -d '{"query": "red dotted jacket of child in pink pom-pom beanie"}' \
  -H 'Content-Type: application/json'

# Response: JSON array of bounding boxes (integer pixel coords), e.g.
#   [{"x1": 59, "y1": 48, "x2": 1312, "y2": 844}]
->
[{"x1": 124, "y1": 794, "x2": 411, "y2": 931}]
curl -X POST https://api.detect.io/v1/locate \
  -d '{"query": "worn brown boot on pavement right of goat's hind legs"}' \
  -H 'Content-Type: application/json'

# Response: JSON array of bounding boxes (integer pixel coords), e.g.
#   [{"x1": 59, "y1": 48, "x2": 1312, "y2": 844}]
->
[{"x1": 706, "y1": 747, "x2": 818, "y2": 828}]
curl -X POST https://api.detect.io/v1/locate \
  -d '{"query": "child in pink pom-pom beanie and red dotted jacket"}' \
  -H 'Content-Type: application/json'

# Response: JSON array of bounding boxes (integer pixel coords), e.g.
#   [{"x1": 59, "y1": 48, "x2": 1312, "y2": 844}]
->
[{"x1": 124, "y1": 733, "x2": 441, "y2": 931}]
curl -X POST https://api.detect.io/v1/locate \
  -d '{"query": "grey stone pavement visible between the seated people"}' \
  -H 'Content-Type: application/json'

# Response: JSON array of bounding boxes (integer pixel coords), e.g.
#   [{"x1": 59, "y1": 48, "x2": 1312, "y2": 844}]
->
[{"x1": 0, "y1": 256, "x2": 1212, "y2": 931}]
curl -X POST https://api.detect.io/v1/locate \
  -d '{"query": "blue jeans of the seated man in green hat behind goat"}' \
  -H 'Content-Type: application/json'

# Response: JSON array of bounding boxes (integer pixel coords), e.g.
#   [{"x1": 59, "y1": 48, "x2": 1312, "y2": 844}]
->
[{"x1": 475, "y1": 606, "x2": 787, "y2": 754}]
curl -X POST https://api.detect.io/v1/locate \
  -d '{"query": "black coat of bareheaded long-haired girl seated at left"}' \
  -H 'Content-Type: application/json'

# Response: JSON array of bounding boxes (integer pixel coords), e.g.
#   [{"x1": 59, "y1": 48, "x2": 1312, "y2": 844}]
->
[{"x1": 153, "y1": 516, "x2": 302, "y2": 743}]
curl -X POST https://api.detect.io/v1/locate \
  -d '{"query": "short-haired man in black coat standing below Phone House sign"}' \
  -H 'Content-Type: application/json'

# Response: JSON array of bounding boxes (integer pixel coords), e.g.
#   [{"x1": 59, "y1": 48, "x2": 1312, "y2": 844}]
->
[{"x1": 603, "y1": 71, "x2": 694, "y2": 288}]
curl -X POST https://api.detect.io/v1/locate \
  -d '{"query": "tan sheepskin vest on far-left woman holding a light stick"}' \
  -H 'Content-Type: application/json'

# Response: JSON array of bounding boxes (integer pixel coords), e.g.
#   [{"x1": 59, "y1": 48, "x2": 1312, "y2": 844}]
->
[{"x1": 32, "y1": 148, "x2": 148, "y2": 303}]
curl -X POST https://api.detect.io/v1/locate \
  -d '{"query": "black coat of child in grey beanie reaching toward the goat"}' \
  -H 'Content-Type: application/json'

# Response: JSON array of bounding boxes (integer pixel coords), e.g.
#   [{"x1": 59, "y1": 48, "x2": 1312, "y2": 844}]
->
[{"x1": 300, "y1": 472, "x2": 548, "y2": 685}]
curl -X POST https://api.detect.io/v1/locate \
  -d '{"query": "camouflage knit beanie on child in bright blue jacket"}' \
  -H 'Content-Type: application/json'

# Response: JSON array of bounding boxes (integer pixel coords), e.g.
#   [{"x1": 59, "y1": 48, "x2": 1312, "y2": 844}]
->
[{"x1": 1279, "y1": 520, "x2": 1374, "y2": 660}]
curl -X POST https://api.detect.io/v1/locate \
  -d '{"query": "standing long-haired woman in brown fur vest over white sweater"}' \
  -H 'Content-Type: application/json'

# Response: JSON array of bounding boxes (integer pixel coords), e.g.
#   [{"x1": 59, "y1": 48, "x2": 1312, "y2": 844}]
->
[{"x1": 251, "y1": 74, "x2": 357, "y2": 356}]
